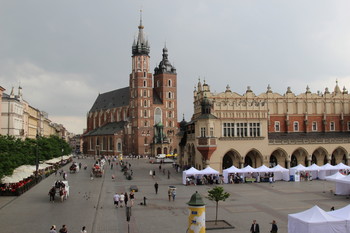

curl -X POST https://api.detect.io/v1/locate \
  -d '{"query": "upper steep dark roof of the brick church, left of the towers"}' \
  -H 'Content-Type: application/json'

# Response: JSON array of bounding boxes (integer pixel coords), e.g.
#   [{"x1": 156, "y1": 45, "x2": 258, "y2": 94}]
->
[{"x1": 90, "y1": 87, "x2": 130, "y2": 112}]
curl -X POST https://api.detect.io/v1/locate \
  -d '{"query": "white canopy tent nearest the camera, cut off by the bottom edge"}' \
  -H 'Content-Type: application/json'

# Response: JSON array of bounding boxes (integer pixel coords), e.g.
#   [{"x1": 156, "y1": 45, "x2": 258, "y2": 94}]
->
[{"x1": 288, "y1": 206, "x2": 346, "y2": 233}]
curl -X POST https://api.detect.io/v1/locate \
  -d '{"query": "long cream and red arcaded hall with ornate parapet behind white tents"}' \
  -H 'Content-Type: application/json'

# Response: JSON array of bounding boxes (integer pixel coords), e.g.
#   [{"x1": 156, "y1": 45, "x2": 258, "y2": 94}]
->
[{"x1": 179, "y1": 81, "x2": 350, "y2": 171}]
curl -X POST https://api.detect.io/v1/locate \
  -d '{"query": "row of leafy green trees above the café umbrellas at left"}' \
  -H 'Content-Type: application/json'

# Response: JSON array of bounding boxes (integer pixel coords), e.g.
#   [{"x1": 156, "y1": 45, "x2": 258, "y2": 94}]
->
[{"x1": 0, "y1": 135, "x2": 72, "y2": 178}]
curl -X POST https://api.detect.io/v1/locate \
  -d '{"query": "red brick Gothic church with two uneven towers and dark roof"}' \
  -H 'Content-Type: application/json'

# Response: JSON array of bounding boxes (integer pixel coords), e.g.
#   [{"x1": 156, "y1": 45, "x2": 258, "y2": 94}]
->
[{"x1": 83, "y1": 15, "x2": 178, "y2": 155}]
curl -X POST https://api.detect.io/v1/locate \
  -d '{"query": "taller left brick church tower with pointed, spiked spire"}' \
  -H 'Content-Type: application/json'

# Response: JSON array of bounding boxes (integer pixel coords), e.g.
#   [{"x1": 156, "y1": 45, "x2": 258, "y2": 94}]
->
[{"x1": 129, "y1": 12, "x2": 153, "y2": 154}]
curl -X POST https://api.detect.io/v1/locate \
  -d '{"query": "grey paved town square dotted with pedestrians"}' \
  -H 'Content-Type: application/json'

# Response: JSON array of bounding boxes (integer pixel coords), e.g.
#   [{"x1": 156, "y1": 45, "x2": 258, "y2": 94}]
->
[{"x1": 0, "y1": 158, "x2": 349, "y2": 233}]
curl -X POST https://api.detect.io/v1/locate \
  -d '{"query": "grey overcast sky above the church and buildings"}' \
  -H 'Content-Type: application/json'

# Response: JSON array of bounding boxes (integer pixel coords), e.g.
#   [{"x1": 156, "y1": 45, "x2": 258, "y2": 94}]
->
[{"x1": 0, "y1": 0, "x2": 350, "y2": 133}]
